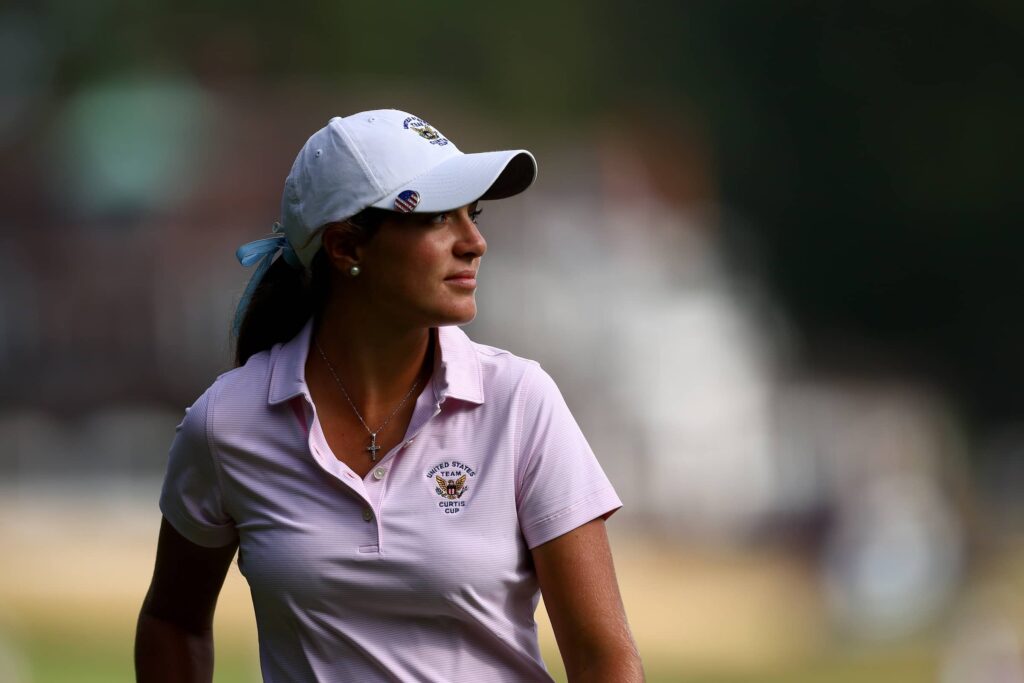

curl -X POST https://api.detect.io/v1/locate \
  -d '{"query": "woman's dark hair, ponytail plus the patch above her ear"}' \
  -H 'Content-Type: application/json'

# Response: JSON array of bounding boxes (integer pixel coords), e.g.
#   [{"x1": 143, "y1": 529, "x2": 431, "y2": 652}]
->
[{"x1": 234, "y1": 208, "x2": 391, "y2": 368}]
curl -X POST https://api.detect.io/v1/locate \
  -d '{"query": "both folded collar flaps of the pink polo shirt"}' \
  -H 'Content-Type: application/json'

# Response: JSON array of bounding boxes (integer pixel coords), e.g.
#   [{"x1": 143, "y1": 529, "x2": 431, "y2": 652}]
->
[{"x1": 267, "y1": 317, "x2": 483, "y2": 405}]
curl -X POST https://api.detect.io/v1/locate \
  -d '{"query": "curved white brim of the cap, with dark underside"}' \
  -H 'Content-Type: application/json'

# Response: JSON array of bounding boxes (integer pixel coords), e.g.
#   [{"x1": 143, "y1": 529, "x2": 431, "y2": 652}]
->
[{"x1": 373, "y1": 150, "x2": 537, "y2": 213}]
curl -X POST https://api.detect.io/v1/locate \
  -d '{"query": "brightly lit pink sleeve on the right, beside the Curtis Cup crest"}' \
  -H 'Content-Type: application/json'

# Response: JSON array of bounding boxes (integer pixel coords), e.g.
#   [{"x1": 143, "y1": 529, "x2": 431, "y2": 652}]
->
[{"x1": 516, "y1": 364, "x2": 623, "y2": 548}]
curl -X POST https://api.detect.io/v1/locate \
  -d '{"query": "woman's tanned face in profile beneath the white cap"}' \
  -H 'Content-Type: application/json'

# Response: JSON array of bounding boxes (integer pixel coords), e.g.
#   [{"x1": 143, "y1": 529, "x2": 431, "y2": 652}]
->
[{"x1": 346, "y1": 202, "x2": 487, "y2": 328}]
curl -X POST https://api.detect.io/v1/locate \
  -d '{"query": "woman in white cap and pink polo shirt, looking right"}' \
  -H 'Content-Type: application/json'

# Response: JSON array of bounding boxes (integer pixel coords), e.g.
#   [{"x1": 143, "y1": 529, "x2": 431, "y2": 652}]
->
[{"x1": 135, "y1": 110, "x2": 643, "y2": 682}]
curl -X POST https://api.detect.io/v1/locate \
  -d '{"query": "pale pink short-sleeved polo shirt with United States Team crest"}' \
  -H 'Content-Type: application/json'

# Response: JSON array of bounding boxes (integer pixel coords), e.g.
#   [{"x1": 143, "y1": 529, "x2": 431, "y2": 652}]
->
[{"x1": 160, "y1": 322, "x2": 622, "y2": 683}]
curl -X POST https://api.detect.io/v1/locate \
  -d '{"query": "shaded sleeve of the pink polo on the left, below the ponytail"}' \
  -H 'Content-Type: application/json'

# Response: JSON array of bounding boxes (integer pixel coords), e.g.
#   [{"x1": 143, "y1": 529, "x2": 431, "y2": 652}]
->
[{"x1": 160, "y1": 387, "x2": 238, "y2": 548}]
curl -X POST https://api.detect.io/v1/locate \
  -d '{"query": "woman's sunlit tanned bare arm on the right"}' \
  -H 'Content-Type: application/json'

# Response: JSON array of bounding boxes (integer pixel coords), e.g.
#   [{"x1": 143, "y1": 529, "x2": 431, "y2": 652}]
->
[{"x1": 532, "y1": 519, "x2": 644, "y2": 683}]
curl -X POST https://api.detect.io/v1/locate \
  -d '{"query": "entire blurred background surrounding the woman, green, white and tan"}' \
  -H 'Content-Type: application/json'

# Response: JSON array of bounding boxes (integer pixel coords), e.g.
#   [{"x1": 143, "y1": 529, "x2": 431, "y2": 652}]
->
[{"x1": 0, "y1": 0, "x2": 1024, "y2": 683}]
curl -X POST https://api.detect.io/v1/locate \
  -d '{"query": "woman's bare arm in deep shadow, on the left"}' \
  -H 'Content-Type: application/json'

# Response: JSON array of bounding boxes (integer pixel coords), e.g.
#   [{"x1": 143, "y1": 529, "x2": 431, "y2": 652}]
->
[{"x1": 135, "y1": 519, "x2": 238, "y2": 683}]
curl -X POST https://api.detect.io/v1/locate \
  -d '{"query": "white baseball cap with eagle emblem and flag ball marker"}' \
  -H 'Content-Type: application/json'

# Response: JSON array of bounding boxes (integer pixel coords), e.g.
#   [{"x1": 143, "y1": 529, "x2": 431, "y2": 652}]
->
[{"x1": 281, "y1": 110, "x2": 537, "y2": 268}]
